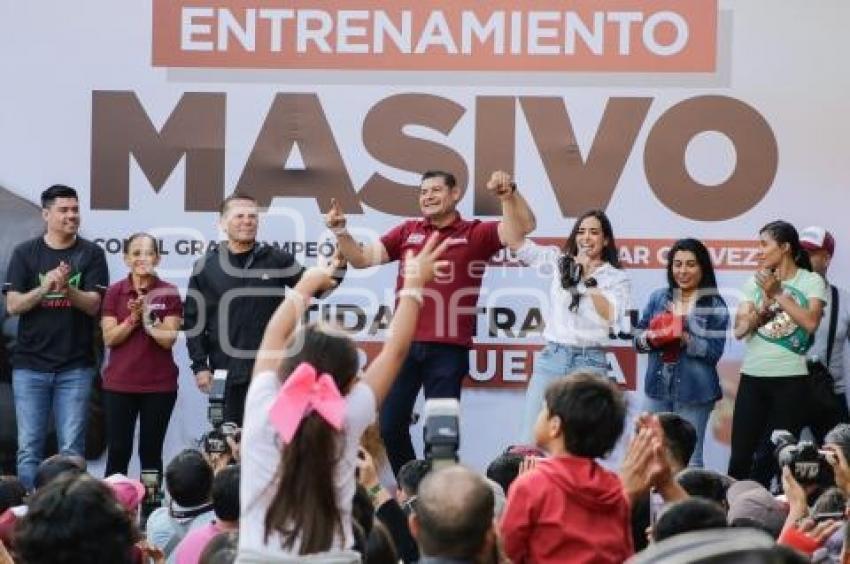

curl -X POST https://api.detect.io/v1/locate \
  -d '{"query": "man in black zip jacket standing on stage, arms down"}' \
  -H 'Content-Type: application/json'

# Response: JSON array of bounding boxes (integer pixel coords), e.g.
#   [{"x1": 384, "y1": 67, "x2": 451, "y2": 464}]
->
[{"x1": 183, "y1": 194, "x2": 304, "y2": 426}]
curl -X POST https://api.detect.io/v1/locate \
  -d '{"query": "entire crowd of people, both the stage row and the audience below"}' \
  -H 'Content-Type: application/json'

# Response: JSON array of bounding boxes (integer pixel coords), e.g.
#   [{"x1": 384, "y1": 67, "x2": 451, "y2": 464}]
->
[{"x1": 0, "y1": 175, "x2": 850, "y2": 564}]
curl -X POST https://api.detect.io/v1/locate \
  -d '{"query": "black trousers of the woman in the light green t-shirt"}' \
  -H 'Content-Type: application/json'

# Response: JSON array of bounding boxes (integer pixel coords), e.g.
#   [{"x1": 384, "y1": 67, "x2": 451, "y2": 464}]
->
[{"x1": 729, "y1": 374, "x2": 809, "y2": 487}]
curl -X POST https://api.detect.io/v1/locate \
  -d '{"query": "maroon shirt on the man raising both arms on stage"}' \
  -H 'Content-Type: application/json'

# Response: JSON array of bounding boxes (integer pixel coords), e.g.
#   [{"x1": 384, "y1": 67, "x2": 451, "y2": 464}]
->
[{"x1": 381, "y1": 215, "x2": 503, "y2": 347}]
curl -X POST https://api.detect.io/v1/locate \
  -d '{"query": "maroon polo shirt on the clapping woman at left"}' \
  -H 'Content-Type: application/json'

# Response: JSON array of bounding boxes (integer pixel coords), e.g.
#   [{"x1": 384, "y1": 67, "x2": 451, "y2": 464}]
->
[{"x1": 103, "y1": 277, "x2": 183, "y2": 393}]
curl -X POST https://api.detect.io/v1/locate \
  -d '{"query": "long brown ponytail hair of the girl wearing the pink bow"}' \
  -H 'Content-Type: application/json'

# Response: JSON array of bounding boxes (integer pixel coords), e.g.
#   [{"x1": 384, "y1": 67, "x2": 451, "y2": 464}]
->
[{"x1": 265, "y1": 323, "x2": 359, "y2": 555}]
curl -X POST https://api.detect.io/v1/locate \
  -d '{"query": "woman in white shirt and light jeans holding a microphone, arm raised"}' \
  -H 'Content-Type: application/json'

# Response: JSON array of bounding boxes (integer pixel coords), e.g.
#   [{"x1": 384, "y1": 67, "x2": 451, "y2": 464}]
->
[{"x1": 502, "y1": 210, "x2": 631, "y2": 442}]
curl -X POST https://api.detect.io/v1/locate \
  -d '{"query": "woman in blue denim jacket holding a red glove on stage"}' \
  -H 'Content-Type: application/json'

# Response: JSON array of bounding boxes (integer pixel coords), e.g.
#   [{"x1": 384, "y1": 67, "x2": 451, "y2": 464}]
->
[{"x1": 635, "y1": 239, "x2": 729, "y2": 467}]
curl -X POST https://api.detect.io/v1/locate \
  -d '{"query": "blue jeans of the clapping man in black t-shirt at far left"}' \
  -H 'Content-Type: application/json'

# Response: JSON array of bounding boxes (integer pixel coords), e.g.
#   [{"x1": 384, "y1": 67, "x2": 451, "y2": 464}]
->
[{"x1": 12, "y1": 367, "x2": 94, "y2": 490}]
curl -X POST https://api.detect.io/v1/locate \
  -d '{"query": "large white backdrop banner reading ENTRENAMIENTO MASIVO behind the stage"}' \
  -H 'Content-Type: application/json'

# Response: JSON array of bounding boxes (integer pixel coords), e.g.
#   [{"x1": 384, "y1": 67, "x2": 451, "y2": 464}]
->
[{"x1": 0, "y1": 0, "x2": 850, "y2": 469}]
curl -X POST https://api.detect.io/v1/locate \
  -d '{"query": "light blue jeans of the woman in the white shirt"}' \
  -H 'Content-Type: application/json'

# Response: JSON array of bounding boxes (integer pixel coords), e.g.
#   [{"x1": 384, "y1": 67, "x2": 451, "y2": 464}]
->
[{"x1": 520, "y1": 341, "x2": 609, "y2": 444}]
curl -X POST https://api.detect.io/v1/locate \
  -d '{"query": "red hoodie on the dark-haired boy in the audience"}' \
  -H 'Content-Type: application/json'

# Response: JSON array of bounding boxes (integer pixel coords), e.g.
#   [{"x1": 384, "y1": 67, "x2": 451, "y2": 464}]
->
[{"x1": 502, "y1": 456, "x2": 634, "y2": 564}]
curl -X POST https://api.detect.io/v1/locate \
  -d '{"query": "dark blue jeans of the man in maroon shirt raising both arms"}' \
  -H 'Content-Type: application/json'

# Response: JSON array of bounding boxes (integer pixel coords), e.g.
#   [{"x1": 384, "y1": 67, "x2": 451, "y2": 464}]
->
[{"x1": 380, "y1": 341, "x2": 469, "y2": 476}]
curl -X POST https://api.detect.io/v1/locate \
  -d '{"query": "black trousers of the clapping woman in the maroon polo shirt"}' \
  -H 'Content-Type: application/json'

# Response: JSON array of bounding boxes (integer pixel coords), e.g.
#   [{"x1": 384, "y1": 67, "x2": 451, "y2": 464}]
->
[{"x1": 103, "y1": 390, "x2": 177, "y2": 476}]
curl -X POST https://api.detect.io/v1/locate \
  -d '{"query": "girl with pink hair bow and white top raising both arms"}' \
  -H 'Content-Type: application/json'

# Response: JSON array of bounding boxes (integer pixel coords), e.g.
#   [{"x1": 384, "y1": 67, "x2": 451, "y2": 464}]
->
[{"x1": 239, "y1": 234, "x2": 446, "y2": 562}]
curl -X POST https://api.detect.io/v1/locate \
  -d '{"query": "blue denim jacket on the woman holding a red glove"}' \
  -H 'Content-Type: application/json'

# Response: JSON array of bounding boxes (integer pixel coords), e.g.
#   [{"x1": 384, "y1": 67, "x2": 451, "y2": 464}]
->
[{"x1": 635, "y1": 288, "x2": 729, "y2": 403}]
